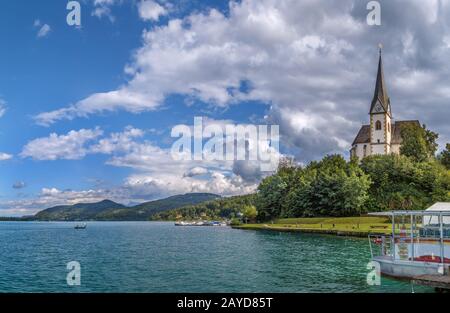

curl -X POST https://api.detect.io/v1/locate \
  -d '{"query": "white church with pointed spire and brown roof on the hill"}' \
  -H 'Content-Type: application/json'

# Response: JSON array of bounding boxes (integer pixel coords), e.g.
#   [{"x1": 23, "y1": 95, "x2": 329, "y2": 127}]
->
[{"x1": 350, "y1": 49, "x2": 420, "y2": 160}]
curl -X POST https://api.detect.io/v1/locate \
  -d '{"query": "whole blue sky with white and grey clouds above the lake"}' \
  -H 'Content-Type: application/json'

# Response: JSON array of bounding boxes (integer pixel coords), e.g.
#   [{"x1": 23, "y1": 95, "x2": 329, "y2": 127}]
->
[{"x1": 0, "y1": 0, "x2": 450, "y2": 216}]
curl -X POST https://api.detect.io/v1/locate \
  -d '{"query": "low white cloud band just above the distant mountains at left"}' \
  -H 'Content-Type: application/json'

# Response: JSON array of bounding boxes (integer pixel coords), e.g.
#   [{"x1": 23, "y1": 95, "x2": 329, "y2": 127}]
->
[{"x1": 0, "y1": 168, "x2": 256, "y2": 216}]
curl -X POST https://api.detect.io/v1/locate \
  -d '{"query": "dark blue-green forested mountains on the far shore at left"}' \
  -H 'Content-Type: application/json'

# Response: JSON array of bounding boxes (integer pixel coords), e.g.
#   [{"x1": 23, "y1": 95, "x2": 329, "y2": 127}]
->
[{"x1": 33, "y1": 193, "x2": 220, "y2": 221}]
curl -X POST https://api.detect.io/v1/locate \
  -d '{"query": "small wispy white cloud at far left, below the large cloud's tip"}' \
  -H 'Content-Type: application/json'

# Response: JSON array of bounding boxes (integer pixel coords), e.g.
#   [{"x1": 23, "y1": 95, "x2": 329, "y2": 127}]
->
[{"x1": 20, "y1": 128, "x2": 102, "y2": 160}]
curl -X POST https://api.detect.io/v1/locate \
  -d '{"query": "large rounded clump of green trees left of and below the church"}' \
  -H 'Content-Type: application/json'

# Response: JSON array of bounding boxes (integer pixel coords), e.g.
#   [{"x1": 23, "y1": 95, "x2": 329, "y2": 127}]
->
[{"x1": 257, "y1": 155, "x2": 370, "y2": 220}]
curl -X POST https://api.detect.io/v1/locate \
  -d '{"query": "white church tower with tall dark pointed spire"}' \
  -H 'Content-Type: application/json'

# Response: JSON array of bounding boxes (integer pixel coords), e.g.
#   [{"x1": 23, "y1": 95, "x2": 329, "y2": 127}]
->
[{"x1": 369, "y1": 47, "x2": 392, "y2": 154}]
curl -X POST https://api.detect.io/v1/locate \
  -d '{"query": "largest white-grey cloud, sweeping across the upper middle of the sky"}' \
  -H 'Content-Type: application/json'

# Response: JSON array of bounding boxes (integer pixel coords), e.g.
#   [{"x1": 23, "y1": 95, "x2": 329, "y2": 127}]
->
[{"x1": 31, "y1": 0, "x2": 361, "y2": 161}]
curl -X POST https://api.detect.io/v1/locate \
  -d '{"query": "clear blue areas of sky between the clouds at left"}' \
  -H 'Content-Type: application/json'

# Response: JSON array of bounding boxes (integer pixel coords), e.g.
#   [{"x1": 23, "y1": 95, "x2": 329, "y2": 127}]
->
[{"x1": 0, "y1": 0, "x2": 265, "y2": 215}]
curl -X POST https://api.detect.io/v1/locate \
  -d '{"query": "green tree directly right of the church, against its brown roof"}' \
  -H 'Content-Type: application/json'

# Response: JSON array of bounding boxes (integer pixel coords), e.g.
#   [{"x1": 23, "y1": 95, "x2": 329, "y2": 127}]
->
[{"x1": 400, "y1": 124, "x2": 438, "y2": 162}]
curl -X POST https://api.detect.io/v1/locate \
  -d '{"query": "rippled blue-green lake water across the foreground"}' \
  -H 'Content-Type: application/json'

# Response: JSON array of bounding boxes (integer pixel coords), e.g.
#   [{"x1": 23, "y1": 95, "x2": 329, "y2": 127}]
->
[{"x1": 0, "y1": 222, "x2": 432, "y2": 292}]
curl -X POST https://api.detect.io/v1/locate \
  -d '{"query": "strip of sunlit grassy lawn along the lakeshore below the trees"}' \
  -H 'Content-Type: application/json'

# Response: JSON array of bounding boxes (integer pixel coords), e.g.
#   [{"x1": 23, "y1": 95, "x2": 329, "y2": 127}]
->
[{"x1": 232, "y1": 217, "x2": 391, "y2": 236}]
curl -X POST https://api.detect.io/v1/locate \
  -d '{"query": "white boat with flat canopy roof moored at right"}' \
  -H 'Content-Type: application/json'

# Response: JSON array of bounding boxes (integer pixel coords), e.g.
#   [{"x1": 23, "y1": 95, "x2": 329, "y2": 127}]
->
[{"x1": 369, "y1": 203, "x2": 450, "y2": 279}]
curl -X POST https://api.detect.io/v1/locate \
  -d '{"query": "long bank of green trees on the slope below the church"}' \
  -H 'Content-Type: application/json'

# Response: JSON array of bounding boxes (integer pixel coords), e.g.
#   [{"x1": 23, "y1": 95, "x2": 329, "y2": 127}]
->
[{"x1": 255, "y1": 125, "x2": 450, "y2": 221}]
